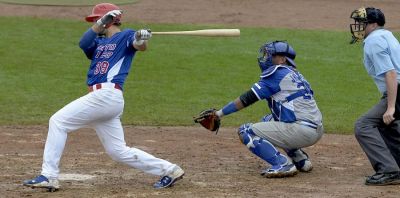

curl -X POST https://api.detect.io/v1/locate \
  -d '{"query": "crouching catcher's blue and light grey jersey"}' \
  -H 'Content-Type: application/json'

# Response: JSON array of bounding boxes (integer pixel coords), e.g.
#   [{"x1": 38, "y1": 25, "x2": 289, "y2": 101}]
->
[{"x1": 251, "y1": 65, "x2": 322, "y2": 125}]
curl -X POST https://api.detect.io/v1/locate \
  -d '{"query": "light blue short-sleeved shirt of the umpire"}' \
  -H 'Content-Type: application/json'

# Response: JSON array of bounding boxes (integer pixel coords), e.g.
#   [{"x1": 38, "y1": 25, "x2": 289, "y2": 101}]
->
[{"x1": 364, "y1": 29, "x2": 400, "y2": 93}]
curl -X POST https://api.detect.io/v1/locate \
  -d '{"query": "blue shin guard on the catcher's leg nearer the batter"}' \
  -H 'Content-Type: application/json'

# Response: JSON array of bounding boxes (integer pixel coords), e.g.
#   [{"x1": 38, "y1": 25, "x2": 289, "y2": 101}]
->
[{"x1": 238, "y1": 123, "x2": 287, "y2": 165}]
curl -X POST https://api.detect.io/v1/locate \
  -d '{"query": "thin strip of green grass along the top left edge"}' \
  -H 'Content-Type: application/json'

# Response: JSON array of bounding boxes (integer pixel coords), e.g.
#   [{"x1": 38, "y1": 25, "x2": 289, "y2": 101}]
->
[{"x1": 0, "y1": 0, "x2": 138, "y2": 6}]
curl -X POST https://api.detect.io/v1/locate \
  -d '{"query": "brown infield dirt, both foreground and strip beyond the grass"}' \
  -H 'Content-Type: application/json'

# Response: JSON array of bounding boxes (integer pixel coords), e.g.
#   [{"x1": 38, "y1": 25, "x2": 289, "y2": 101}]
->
[{"x1": 0, "y1": 0, "x2": 400, "y2": 197}]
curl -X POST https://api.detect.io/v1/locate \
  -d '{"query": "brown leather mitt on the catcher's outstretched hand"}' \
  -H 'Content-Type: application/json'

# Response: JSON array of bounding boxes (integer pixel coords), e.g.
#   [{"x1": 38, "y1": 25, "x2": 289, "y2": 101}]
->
[{"x1": 193, "y1": 108, "x2": 221, "y2": 134}]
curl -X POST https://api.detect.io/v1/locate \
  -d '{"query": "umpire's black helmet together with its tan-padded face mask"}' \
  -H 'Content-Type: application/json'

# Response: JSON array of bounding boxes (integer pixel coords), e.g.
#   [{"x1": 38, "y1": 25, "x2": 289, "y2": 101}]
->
[{"x1": 350, "y1": 7, "x2": 385, "y2": 44}]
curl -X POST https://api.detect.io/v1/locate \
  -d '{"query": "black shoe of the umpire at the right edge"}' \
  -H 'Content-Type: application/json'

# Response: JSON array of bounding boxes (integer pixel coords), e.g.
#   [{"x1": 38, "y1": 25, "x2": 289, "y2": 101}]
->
[{"x1": 365, "y1": 172, "x2": 400, "y2": 186}]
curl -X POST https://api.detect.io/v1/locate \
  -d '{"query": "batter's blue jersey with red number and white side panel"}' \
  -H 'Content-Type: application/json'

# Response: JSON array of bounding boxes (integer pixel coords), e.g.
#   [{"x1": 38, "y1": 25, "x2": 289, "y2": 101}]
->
[{"x1": 80, "y1": 28, "x2": 136, "y2": 87}]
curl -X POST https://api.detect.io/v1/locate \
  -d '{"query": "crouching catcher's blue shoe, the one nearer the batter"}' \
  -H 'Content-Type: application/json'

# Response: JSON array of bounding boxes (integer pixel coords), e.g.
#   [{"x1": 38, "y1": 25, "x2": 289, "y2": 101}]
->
[{"x1": 261, "y1": 162, "x2": 298, "y2": 178}]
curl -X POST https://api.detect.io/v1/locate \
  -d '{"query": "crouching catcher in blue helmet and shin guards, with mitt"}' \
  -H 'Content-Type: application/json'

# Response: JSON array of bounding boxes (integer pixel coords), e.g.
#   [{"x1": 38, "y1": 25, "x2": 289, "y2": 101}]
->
[{"x1": 194, "y1": 41, "x2": 323, "y2": 178}]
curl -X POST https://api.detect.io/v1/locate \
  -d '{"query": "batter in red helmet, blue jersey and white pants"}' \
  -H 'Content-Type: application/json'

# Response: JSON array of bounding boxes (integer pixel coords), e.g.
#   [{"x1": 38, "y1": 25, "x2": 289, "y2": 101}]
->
[{"x1": 23, "y1": 3, "x2": 184, "y2": 191}]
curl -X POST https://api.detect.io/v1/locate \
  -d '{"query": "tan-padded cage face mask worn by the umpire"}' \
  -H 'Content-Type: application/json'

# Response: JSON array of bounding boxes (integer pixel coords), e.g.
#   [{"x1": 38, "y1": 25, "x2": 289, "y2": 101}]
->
[{"x1": 350, "y1": 8, "x2": 368, "y2": 44}]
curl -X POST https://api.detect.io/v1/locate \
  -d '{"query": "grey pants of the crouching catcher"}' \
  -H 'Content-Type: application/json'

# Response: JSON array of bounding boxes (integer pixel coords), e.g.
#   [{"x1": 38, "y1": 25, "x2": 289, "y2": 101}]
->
[{"x1": 251, "y1": 121, "x2": 324, "y2": 150}]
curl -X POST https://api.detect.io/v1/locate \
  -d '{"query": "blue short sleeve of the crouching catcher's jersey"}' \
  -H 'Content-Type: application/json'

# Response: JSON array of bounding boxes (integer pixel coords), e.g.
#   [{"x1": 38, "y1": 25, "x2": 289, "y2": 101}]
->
[{"x1": 251, "y1": 72, "x2": 283, "y2": 100}]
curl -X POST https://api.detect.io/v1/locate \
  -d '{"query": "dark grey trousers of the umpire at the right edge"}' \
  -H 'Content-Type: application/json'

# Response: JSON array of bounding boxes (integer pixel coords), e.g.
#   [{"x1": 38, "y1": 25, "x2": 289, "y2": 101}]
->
[{"x1": 354, "y1": 90, "x2": 400, "y2": 173}]
